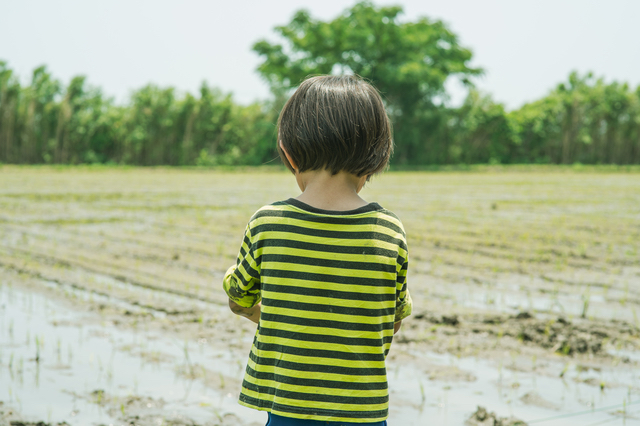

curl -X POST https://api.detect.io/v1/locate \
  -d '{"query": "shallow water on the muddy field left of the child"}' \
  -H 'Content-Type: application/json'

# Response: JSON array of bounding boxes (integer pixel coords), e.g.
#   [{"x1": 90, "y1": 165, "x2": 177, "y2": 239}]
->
[{"x1": 0, "y1": 284, "x2": 265, "y2": 425}]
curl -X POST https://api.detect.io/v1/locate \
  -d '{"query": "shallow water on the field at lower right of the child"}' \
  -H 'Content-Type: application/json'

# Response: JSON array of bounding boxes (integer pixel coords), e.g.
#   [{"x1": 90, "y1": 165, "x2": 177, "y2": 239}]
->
[{"x1": 389, "y1": 353, "x2": 640, "y2": 426}]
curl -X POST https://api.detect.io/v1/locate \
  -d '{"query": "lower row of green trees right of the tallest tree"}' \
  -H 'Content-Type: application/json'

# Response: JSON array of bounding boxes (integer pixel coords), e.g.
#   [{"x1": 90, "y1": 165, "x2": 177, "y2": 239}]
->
[{"x1": 434, "y1": 72, "x2": 640, "y2": 164}]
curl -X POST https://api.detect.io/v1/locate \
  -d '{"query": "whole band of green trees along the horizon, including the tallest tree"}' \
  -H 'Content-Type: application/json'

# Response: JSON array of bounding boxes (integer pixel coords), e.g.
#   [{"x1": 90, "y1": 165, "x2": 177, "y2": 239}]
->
[{"x1": 0, "y1": 2, "x2": 640, "y2": 166}]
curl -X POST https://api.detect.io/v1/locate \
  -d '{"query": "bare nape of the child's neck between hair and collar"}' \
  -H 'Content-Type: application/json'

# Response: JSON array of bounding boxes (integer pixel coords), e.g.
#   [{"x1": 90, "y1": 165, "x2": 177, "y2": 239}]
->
[{"x1": 296, "y1": 170, "x2": 368, "y2": 211}]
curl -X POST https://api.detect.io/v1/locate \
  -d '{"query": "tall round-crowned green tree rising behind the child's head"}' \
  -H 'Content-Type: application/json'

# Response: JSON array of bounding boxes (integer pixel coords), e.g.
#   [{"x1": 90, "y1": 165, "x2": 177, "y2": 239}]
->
[{"x1": 253, "y1": 2, "x2": 482, "y2": 163}]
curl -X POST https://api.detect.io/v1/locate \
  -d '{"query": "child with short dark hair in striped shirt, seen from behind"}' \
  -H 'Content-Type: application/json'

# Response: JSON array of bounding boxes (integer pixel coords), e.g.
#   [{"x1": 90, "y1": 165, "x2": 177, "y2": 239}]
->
[{"x1": 224, "y1": 76, "x2": 411, "y2": 426}]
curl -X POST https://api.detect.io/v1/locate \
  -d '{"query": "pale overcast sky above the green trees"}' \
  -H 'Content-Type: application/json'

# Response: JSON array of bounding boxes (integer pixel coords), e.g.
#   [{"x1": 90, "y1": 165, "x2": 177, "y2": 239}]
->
[{"x1": 0, "y1": 0, "x2": 640, "y2": 109}]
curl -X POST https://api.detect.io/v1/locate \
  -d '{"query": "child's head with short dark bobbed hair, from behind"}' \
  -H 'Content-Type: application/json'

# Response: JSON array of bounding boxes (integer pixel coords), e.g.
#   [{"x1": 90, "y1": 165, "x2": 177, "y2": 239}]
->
[{"x1": 278, "y1": 75, "x2": 393, "y2": 176}]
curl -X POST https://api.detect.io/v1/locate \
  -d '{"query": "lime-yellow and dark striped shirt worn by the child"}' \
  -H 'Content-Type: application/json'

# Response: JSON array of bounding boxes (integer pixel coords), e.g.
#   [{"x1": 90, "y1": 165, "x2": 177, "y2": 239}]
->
[{"x1": 224, "y1": 199, "x2": 411, "y2": 423}]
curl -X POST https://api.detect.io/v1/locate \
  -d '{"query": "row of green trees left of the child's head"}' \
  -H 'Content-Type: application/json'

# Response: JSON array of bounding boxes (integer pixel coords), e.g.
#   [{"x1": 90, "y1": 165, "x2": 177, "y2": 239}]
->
[{"x1": 0, "y1": 62, "x2": 277, "y2": 166}]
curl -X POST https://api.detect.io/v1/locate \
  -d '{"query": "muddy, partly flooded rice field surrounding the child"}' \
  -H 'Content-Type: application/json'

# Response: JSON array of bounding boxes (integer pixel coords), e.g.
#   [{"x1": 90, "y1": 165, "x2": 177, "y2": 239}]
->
[{"x1": 0, "y1": 166, "x2": 640, "y2": 426}]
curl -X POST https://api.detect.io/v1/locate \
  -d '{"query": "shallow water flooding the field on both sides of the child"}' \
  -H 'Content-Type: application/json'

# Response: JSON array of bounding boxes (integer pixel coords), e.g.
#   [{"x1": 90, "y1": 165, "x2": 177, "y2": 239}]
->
[{"x1": 0, "y1": 282, "x2": 640, "y2": 426}]
